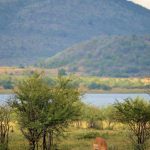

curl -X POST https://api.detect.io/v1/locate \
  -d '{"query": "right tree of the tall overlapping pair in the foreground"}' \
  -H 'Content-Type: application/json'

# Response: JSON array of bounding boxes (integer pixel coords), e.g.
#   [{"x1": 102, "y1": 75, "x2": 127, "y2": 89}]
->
[{"x1": 43, "y1": 76, "x2": 80, "y2": 149}]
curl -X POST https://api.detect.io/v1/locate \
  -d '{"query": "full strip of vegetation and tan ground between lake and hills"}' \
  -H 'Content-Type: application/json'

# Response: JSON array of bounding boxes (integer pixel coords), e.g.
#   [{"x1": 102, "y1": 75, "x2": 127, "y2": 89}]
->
[{"x1": 0, "y1": 67, "x2": 150, "y2": 92}]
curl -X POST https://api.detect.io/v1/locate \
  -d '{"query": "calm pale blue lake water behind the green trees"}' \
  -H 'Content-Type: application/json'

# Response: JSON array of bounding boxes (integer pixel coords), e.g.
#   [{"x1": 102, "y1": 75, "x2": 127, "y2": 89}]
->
[{"x1": 0, "y1": 94, "x2": 150, "y2": 106}]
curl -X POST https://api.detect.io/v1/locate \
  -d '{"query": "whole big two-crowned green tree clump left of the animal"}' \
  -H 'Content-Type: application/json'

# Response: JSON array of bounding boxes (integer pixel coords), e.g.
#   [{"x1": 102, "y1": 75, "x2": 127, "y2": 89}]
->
[{"x1": 12, "y1": 73, "x2": 80, "y2": 150}]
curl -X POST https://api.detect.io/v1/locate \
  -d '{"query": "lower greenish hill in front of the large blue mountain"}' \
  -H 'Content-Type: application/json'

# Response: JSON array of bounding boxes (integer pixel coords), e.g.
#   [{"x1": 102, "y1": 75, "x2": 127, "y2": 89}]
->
[{"x1": 42, "y1": 35, "x2": 150, "y2": 77}]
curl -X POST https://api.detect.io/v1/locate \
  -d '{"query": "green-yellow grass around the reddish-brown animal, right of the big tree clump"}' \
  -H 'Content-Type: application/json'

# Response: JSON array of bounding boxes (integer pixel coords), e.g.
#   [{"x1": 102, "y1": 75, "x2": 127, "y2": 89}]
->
[{"x1": 50, "y1": 129, "x2": 132, "y2": 150}]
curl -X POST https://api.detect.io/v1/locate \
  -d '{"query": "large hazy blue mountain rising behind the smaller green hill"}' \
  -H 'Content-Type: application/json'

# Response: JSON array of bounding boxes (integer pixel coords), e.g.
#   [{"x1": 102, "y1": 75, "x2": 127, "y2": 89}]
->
[{"x1": 0, "y1": 0, "x2": 150, "y2": 66}]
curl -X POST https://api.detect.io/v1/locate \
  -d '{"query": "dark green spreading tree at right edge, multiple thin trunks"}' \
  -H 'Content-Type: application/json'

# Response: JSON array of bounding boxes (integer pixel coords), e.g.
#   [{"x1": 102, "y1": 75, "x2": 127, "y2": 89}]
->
[{"x1": 114, "y1": 97, "x2": 150, "y2": 150}]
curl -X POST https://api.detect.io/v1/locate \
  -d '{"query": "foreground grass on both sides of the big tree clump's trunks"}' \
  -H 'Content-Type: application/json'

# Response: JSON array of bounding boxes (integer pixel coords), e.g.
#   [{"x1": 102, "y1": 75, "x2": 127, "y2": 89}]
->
[{"x1": 9, "y1": 127, "x2": 135, "y2": 150}]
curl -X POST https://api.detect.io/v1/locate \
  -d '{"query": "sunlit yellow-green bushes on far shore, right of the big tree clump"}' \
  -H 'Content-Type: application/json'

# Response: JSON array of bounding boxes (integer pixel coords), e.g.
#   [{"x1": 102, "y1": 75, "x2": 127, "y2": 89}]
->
[{"x1": 80, "y1": 76, "x2": 150, "y2": 90}]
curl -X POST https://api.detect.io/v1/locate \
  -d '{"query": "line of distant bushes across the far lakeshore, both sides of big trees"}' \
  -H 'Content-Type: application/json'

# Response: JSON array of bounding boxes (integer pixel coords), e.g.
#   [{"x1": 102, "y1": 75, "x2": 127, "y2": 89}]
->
[{"x1": 0, "y1": 72, "x2": 150, "y2": 91}]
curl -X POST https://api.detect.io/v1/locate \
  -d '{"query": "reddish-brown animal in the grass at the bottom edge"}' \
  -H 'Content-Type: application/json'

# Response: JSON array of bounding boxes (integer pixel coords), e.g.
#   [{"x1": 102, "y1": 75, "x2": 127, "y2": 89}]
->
[{"x1": 93, "y1": 137, "x2": 107, "y2": 150}]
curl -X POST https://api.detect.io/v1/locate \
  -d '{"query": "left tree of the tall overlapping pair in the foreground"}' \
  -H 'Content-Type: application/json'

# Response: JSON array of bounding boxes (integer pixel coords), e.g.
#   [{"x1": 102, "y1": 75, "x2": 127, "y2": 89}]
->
[{"x1": 12, "y1": 74, "x2": 50, "y2": 150}]
